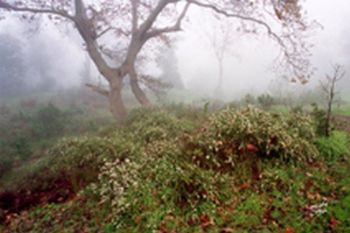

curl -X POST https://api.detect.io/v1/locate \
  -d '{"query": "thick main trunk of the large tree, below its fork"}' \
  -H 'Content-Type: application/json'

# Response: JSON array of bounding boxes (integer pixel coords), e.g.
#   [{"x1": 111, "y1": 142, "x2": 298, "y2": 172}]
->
[{"x1": 109, "y1": 79, "x2": 128, "y2": 123}]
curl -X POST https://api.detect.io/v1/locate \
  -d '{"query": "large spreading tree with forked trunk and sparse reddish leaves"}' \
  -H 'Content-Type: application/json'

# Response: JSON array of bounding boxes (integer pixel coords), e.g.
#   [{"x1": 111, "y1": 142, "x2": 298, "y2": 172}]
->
[{"x1": 0, "y1": 0, "x2": 316, "y2": 122}]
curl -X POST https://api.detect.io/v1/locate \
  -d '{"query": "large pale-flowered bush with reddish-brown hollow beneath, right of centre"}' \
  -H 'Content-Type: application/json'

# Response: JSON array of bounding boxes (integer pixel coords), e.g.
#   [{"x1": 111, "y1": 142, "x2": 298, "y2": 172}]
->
[{"x1": 185, "y1": 106, "x2": 318, "y2": 171}]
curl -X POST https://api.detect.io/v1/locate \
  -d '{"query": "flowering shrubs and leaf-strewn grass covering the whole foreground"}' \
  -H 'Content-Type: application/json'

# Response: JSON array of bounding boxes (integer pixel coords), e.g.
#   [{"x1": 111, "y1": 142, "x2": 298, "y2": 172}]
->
[{"x1": 0, "y1": 105, "x2": 350, "y2": 233}]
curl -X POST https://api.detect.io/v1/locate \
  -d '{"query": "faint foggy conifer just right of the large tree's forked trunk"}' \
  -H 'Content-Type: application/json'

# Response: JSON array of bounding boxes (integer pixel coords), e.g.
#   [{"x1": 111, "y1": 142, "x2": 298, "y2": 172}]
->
[{"x1": 157, "y1": 46, "x2": 184, "y2": 90}]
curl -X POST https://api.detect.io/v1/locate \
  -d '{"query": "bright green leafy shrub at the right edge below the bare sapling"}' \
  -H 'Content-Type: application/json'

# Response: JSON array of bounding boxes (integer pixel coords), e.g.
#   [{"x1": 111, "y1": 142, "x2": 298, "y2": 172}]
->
[{"x1": 316, "y1": 131, "x2": 350, "y2": 159}]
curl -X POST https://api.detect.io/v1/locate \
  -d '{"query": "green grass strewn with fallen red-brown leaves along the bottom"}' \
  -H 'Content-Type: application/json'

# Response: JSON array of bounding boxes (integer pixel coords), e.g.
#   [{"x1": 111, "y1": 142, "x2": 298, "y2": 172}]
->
[{"x1": 0, "y1": 108, "x2": 350, "y2": 233}]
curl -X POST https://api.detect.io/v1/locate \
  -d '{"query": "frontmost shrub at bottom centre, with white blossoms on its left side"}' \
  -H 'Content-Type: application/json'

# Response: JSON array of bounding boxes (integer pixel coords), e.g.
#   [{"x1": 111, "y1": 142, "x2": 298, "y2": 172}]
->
[{"x1": 96, "y1": 142, "x2": 228, "y2": 232}]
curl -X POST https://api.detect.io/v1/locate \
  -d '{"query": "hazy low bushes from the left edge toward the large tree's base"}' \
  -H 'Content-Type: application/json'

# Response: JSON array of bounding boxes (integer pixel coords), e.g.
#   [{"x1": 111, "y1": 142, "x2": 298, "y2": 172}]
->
[{"x1": 0, "y1": 103, "x2": 110, "y2": 177}]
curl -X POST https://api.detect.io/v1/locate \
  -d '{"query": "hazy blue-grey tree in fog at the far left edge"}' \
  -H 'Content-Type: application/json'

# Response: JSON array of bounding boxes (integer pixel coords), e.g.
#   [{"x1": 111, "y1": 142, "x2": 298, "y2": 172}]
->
[{"x1": 0, "y1": 34, "x2": 26, "y2": 97}]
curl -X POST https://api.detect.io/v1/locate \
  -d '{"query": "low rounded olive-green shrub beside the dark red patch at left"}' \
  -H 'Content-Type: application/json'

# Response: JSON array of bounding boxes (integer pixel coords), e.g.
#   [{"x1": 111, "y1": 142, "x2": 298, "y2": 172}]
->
[{"x1": 49, "y1": 132, "x2": 138, "y2": 188}]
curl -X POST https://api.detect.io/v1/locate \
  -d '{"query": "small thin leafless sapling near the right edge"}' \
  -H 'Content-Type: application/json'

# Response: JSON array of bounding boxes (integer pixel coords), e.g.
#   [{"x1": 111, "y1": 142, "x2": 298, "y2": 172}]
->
[{"x1": 320, "y1": 64, "x2": 345, "y2": 137}]
